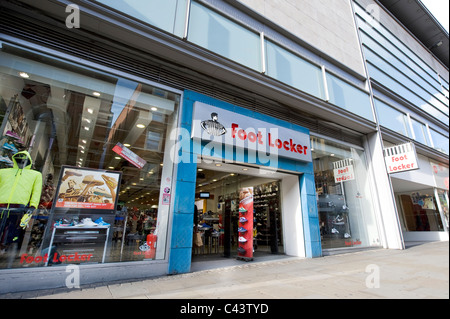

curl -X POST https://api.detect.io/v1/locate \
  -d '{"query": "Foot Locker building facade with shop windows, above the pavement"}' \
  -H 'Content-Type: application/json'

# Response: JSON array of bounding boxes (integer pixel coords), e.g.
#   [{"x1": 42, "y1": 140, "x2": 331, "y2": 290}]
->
[{"x1": 0, "y1": 0, "x2": 449, "y2": 293}]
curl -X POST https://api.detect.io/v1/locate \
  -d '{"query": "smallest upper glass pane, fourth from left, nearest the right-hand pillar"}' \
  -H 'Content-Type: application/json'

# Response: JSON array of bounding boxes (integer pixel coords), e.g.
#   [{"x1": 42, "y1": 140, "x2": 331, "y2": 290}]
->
[{"x1": 327, "y1": 73, "x2": 373, "y2": 121}]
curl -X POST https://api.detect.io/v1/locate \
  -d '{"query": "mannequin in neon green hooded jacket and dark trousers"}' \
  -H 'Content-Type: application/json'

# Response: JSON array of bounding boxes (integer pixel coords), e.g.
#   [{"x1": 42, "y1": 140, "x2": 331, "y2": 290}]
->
[{"x1": 0, "y1": 151, "x2": 42, "y2": 254}]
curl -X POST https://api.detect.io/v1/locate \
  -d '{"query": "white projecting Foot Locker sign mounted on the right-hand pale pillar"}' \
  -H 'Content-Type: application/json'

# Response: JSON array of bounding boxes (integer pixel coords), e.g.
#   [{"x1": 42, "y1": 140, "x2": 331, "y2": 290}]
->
[{"x1": 384, "y1": 143, "x2": 419, "y2": 174}]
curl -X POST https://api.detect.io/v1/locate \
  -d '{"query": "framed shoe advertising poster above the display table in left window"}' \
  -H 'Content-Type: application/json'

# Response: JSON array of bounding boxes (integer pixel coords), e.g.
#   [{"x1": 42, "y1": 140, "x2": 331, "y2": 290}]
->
[{"x1": 55, "y1": 166, "x2": 121, "y2": 210}]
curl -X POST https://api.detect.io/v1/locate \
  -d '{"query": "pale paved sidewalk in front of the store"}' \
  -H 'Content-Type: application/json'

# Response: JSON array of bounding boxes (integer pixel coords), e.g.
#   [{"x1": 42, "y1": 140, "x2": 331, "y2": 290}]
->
[{"x1": 0, "y1": 242, "x2": 449, "y2": 299}]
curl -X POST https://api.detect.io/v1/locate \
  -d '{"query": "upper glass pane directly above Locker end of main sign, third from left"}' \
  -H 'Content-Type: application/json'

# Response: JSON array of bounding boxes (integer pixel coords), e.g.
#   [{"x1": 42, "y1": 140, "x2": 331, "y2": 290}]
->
[{"x1": 265, "y1": 40, "x2": 325, "y2": 99}]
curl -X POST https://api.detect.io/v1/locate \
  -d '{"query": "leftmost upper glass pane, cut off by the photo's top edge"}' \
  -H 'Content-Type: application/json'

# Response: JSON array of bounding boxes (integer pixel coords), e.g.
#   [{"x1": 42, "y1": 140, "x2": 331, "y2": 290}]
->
[{"x1": 96, "y1": 0, "x2": 187, "y2": 37}]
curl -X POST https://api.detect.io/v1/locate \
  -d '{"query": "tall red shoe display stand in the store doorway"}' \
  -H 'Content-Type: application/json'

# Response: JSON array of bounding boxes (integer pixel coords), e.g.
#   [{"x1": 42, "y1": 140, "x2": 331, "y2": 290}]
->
[{"x1": 238, "y1": 187, "x2": 253, "y2": 261}]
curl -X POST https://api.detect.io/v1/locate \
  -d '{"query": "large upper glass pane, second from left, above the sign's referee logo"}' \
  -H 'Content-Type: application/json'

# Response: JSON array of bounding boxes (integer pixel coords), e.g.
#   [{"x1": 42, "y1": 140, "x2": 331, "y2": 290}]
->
[{"x1": 188, "y1": 2, "x2": 261, "y2": 71}]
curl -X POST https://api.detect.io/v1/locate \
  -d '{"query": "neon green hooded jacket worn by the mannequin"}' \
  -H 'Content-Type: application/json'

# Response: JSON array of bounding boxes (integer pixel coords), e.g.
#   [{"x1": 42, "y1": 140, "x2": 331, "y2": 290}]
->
[{"x1": 0, "y1": 151, "x2": 42, "y2": 208}]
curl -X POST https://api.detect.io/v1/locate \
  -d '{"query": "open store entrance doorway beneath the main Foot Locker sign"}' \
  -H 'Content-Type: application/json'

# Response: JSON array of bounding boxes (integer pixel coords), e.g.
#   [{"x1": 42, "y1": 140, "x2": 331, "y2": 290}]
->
[{"x1": 192, "y1": 164, "x2": 285, "y2": 262}]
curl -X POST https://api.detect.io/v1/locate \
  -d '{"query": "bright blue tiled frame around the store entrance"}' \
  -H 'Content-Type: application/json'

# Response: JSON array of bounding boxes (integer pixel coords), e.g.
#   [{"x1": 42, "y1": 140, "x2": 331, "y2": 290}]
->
[{"x1": 168, "y1": 91, "x2": 322, "y2": 274}]
